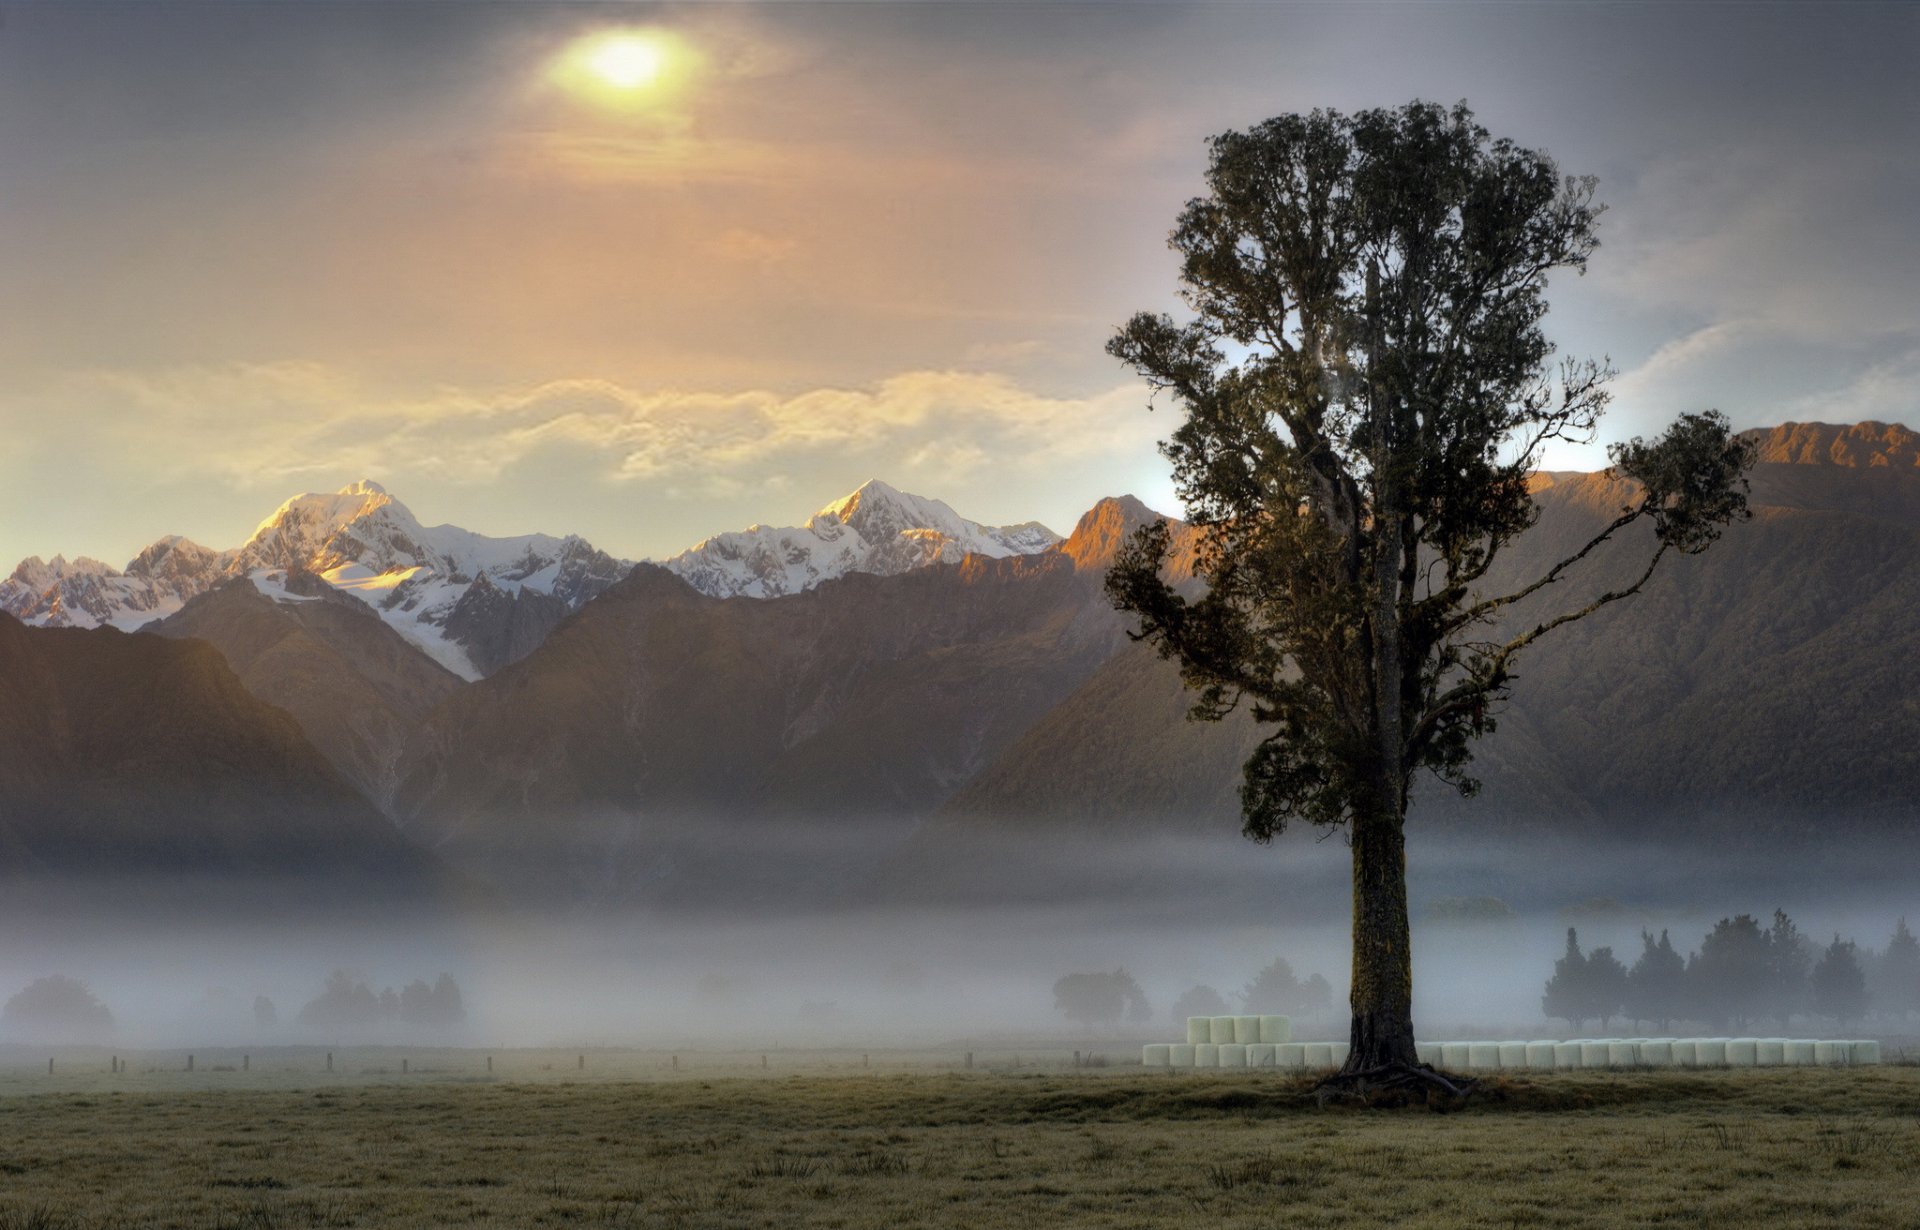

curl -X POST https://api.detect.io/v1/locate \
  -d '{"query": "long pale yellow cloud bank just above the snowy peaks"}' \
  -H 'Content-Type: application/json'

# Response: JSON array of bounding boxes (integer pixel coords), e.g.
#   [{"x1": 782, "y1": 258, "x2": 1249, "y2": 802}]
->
[{"x1": 30, "y1": 363, "x2": 1165, "y2": 491}]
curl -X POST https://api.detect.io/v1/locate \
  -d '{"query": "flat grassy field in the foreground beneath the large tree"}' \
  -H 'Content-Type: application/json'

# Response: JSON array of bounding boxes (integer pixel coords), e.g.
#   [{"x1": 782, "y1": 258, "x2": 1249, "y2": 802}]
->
[{"x1": 0, "y1": 1057, "x2": 1920, "y2": 1230}]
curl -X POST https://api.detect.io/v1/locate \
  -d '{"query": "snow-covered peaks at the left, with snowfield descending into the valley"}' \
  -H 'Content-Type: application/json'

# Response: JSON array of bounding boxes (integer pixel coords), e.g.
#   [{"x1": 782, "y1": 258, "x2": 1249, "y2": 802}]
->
[{"x1": 0, "y1": 482, "x2": 632, "y2": 679}]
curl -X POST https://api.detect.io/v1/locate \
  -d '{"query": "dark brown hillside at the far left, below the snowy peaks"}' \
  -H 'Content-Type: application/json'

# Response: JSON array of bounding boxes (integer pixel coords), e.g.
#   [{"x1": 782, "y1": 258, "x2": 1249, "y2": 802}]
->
[{"x1": 0, "y1": 616, "x2": 428, "y2": 887}]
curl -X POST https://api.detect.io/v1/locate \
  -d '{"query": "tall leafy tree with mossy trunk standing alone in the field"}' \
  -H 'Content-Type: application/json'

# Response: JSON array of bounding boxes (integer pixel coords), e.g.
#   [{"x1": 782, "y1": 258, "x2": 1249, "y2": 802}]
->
[{"x1": 1108, "y1": 104, "x2": 1751, "y2": 1078}]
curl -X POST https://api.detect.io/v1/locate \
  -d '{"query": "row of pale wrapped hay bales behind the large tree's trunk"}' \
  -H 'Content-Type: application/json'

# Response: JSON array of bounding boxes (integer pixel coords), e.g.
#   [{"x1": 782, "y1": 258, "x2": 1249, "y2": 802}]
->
[{"x1": 1140, "y1": 1017, "x2": 1880, "y2": 1073}]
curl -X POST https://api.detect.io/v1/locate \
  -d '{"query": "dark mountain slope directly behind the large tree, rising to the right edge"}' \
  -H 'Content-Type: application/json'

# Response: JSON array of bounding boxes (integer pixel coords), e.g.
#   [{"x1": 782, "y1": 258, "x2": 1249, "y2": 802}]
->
[{"x1": 929, "y1": 424, "x2": 1920, "y2": 840}]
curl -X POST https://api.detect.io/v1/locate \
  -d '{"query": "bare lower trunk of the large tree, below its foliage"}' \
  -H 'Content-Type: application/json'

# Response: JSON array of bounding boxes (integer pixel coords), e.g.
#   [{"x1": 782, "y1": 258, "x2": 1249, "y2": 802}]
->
[{"x1": 1340, "y1": 802, "x2": 1417, "y2": 1073}]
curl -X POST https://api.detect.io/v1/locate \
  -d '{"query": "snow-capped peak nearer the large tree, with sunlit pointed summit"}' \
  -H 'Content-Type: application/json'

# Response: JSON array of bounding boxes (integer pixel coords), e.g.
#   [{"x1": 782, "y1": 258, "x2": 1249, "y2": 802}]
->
[{"x1": 660, "y1": 480, "x2": 1060, "y2": 599}]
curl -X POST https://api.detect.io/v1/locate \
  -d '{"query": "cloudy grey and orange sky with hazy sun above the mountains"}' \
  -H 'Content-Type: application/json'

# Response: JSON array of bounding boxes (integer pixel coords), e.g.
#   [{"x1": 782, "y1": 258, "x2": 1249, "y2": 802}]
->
[{"x1": 0, "y1": 0, "x2": 1920, "y2": 570}]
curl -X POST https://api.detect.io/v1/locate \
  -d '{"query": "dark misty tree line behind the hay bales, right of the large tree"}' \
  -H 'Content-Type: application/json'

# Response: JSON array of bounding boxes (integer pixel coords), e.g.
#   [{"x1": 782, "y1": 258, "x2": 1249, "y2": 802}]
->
[{"x1": 1540, "y1": 910, "x2": 1920, "y2": 1032}]
